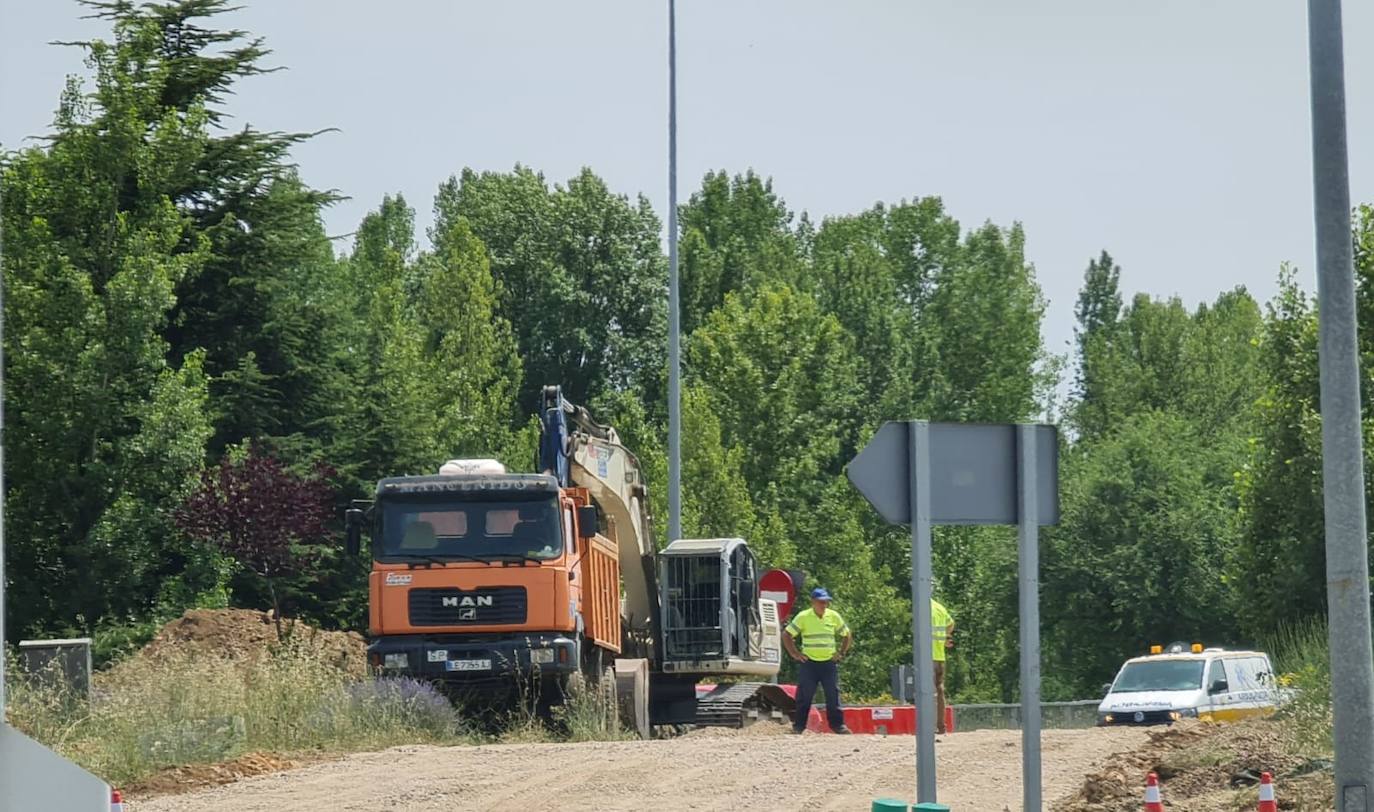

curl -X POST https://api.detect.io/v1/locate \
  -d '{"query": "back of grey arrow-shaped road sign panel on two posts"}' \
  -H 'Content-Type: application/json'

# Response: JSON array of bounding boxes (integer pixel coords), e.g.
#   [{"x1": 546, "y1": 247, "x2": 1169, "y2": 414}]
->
[{"x1": 846, "y1": 420, "x2": 1059, "y2": 525}]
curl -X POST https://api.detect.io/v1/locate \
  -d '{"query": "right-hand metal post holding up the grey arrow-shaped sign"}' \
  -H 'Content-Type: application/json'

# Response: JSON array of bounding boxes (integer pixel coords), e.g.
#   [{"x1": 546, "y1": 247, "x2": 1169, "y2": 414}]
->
[{"x1": 1017, "y1": 425, "x2": 1041, "y2": 812}]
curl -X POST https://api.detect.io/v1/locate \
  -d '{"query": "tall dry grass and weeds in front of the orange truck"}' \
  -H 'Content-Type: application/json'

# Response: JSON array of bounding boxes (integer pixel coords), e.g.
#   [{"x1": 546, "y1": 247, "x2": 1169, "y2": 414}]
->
[{"x1": 7, "y1": 642, "x2": 628, "y2": 786}]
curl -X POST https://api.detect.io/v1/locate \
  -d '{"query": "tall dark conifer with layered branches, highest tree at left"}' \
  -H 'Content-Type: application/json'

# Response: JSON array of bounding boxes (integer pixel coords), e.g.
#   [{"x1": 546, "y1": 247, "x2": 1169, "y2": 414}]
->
[{"x1": 62, "y1": 0, "x2": 348, "y2": 449}]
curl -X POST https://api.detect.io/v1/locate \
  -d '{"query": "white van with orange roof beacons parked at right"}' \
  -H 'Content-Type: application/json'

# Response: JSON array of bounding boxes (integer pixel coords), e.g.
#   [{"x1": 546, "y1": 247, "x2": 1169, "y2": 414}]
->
[{"x1": 1098, "y1": 644, "x2": 1279, "y2": 725}]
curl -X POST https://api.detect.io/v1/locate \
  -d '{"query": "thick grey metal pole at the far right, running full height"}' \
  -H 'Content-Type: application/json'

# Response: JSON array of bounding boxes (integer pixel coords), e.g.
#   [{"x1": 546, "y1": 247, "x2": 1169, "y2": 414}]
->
[{"x1": 1307, "y1": 0, "x2": 1374, "y2": 812}]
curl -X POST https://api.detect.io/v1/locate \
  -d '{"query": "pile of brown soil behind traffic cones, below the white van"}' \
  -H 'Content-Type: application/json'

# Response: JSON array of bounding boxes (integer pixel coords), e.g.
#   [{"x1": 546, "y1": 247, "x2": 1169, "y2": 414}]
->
[{"x1": 1054, "y1": 720, "x2": 1331, "y2": 812}]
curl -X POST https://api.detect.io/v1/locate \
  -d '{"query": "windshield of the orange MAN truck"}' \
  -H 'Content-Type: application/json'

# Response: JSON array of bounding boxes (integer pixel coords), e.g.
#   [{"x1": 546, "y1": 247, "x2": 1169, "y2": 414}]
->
[{"x1": 378, "y1": 496, "x2": 563, "y2": 561}]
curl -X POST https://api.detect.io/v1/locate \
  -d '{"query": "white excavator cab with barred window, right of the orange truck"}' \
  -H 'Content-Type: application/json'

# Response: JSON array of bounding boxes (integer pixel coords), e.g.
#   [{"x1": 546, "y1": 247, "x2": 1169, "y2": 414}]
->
[{"x1": 658, "y1": 539, "x2": 782, "y2": 676}]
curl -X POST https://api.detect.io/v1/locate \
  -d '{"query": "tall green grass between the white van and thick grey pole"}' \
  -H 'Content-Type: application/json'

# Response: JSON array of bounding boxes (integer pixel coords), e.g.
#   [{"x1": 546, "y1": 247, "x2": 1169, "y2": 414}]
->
[{"x1": 1267, "y1": 620, "x2": 1333, "y2": 756}]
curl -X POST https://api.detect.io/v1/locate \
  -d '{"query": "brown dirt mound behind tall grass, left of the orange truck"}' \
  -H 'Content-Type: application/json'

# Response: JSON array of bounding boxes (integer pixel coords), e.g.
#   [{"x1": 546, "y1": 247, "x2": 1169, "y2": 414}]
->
[{"x1": 139, "y1": 609, "x2": 367, "y2": 676}]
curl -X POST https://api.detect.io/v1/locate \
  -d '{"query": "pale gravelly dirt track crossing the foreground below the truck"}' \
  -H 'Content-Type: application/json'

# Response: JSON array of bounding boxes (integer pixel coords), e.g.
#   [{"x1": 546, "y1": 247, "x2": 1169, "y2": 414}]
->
[{"x1": 129, "y1": 730, "x2": 1146, "y2": 812}]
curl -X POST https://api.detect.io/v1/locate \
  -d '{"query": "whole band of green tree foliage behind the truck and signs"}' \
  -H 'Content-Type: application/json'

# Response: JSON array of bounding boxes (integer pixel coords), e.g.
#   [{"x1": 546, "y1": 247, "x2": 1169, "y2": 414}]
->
[{"x1": 0, "y1": 0, "x2": 1374, "y2": 699}]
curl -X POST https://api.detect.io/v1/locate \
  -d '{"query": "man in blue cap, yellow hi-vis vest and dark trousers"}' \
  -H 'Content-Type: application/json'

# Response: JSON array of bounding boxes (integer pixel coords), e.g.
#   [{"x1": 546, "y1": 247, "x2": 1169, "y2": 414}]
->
[{"x1": 782, "y1": 587, "x2": 855, "y2": 734}]
